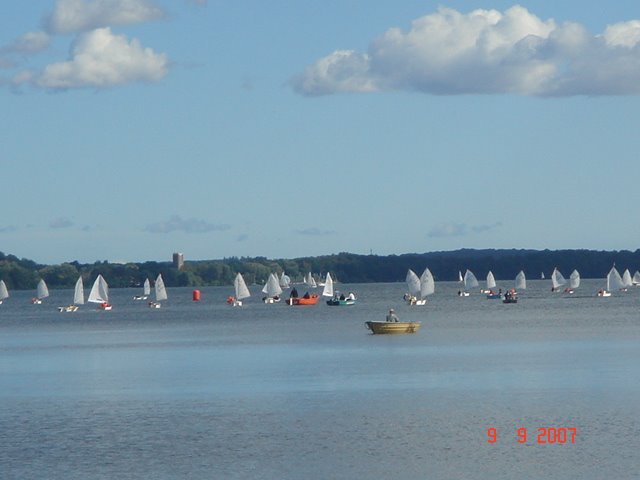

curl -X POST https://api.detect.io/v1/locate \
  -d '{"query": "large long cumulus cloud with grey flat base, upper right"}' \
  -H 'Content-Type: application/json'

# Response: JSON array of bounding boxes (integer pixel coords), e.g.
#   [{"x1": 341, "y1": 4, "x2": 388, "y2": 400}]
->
[{"x1": 291, "y1": 5, "x2": 640, "y2": 96}]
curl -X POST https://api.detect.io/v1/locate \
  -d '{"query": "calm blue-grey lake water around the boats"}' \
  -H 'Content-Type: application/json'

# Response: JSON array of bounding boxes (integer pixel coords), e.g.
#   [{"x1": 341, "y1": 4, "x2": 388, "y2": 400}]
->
[{"x1": 0, "y1": 280, "x2": 640, "y2": 480}]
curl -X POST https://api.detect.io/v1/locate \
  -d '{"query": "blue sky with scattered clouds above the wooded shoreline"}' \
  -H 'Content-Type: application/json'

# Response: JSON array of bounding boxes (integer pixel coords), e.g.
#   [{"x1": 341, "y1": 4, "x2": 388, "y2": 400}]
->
[{"x1": 0, "y1": 0, "x2": 640, "y2": 264}]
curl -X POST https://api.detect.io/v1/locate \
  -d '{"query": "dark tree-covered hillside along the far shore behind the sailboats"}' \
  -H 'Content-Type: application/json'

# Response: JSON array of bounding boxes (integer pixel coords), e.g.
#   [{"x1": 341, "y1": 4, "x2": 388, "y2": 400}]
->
[{"x1": 0, "y1": 249, "x2": 640, "y2": 290}]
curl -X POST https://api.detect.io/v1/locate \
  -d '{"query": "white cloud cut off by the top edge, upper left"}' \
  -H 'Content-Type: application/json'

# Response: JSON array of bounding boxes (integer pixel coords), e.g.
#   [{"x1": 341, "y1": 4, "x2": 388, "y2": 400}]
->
[{"x1": 45, "y1": 0, "x2": 165, "y2": 33}]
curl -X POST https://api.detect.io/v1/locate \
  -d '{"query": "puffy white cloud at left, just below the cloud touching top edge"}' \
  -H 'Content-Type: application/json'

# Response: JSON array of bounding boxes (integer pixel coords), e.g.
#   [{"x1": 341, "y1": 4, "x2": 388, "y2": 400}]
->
[{"x1": 29, "y1": 28, "x2": 168, "y2": 89}]
